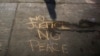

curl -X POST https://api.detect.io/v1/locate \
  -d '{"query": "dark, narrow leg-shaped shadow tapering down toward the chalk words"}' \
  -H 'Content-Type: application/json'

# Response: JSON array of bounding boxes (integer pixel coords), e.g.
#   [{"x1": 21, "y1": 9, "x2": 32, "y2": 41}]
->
[{"x1": 44, "y1": 0, "x2": 56, "y2": 21}]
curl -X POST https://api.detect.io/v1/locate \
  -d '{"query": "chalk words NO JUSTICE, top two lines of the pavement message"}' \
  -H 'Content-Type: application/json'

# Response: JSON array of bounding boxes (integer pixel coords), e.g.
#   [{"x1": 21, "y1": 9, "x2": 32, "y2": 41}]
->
[{"x1": 27, "y1": 16, "x2": 70, "y2": 30}]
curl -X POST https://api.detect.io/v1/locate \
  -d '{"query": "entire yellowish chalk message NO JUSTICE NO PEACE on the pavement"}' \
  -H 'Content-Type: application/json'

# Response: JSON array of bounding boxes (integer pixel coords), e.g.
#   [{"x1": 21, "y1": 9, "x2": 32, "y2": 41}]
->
[{"x1": 27, "y1": 16, "x2": 70, "y2": 54}]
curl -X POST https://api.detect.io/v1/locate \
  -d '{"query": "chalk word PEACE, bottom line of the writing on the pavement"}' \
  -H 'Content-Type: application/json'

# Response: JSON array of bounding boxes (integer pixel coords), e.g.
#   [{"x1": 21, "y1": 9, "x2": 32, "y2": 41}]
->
[{"x1": 30, "y1": 40, "x2": 68, "y2": 53}]
